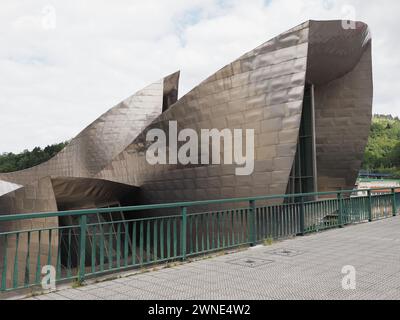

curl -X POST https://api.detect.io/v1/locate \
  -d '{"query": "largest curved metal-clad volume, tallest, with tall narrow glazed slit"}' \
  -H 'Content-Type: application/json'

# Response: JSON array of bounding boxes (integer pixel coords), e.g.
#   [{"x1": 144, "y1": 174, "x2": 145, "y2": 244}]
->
[{"x1": 97, "y1": 21, "x2": 373, "y2": 202}]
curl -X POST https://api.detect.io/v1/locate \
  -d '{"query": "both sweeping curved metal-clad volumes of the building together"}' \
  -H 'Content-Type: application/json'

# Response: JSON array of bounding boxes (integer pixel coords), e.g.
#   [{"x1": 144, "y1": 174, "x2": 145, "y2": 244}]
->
[{"x1": 0, "y1": 21, "x2": 373, "y2": 213}]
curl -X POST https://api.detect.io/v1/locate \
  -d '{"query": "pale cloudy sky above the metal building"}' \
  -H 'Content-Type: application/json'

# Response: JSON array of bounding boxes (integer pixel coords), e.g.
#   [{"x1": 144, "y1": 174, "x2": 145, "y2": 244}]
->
[{"x1": 0, "y1": 0, "x2": 400, "y2": 153}]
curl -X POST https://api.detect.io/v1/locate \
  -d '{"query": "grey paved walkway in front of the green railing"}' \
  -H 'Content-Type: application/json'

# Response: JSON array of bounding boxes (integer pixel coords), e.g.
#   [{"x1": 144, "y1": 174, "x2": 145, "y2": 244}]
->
[{"x1": 24, "y1": 217, "x2": 400, "y2": 300}]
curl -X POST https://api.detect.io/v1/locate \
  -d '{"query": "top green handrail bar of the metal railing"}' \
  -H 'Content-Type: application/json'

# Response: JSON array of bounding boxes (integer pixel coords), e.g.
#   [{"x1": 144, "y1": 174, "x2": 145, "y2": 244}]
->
[{"x1": 0, "y1": 188, "x2": 398, "y2": 222}]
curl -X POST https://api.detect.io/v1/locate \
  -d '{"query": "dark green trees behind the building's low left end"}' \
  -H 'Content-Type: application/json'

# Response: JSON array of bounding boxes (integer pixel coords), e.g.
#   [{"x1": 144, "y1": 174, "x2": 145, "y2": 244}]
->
[{"x1": 0, "y1": 142, "x2": 68, "y2": 172}]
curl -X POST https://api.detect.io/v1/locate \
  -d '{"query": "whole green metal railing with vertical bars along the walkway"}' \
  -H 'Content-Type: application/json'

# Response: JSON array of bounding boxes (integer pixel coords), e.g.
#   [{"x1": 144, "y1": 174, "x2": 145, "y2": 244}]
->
[{"x1": 0, "y1": 189, "x2": 400, "y2": 291}]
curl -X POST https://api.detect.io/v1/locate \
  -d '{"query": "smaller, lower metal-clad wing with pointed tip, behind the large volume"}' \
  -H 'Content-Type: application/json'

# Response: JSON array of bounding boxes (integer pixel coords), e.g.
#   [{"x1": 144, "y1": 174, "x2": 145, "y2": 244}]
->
[{"x1": 0, "y1": 72, "x2": 179, "y2": 185}]
